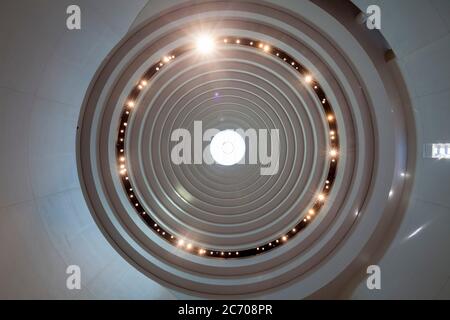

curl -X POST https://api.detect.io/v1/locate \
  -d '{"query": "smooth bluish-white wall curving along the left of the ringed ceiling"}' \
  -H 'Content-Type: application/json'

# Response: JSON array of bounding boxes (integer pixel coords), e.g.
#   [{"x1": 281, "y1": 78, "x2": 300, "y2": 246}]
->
[{"x1": 0, "y1": 0, "x2": 173, "y2": 299}]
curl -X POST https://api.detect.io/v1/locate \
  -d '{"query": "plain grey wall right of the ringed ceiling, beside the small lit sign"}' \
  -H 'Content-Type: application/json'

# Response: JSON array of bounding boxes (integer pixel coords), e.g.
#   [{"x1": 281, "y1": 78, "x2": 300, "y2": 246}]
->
[{"x1": 352, "y1": 0, "x2": 450, "y2": 299}]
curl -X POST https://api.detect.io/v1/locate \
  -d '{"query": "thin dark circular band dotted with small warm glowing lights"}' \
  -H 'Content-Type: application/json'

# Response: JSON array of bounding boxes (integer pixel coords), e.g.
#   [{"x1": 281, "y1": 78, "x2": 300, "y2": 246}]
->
[{"x1": 116, "y1": 36, "x2": 339, "y2": 259}]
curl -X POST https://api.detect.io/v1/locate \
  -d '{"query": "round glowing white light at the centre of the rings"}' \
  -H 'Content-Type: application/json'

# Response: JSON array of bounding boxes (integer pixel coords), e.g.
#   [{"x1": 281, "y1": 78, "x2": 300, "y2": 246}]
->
[{"x1": 209, "y1": 130, "x2": 245, "y2": 166}]
